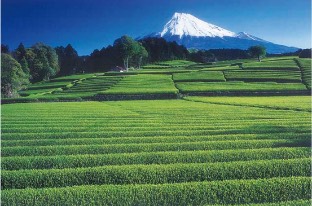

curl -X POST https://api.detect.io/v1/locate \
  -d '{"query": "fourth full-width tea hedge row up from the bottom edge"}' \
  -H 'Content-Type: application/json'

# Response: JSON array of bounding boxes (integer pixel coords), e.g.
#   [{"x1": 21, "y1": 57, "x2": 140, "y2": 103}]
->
[{"x1": 1, "y1": 139, "x2": 310, "y2": 157}]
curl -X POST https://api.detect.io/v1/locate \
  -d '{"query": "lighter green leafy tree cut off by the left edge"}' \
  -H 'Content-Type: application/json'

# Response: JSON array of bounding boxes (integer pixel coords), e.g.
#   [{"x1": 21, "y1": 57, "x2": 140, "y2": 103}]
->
[{"x1": 1, "y1": 54, "x2": 29, "y2": 97}]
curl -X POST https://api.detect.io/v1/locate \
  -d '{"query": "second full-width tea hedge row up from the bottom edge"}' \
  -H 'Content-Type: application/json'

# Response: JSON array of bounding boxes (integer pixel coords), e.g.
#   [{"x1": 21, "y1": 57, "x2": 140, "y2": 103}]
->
[{"x1": 1, "y1": 158, "x2": 311, "y2": 189}]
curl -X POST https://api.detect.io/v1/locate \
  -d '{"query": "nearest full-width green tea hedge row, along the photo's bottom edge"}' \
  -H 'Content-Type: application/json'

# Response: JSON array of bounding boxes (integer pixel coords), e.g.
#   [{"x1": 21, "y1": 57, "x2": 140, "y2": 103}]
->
[{"x1": 1, "y1": 177, "x2": 311, "y2": 206}]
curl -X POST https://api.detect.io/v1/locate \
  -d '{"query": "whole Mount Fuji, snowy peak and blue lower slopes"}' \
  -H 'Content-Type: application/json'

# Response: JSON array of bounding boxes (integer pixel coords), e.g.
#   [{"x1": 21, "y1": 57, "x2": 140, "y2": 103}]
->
[{"x1": 139, "y1": 13, "x2": 299, "y2": 54}]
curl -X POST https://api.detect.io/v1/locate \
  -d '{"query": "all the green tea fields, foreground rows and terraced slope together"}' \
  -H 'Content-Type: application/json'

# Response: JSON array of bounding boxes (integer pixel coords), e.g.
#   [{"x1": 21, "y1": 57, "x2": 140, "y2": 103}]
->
[{"x1": 1, "y1": 57, "x2": 311, "y2": 206}]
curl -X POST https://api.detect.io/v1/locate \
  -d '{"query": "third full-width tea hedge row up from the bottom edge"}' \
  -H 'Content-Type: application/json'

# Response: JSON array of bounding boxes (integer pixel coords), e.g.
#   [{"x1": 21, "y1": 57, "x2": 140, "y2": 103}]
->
[{"x1": 1, "y1": 147, "x2": 310, "y2": 170}]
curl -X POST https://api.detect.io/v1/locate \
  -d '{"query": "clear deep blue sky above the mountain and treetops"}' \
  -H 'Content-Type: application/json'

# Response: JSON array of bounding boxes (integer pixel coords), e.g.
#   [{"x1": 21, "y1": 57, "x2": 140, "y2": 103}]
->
[{"x1": 1, "y1": 0, "x2": 311, "y2": 55}]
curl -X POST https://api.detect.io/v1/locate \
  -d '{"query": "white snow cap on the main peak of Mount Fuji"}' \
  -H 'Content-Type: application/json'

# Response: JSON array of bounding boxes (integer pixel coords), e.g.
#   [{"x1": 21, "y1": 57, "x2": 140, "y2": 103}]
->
[{"x1": 160, "y1": 13, "x2": 236, "y2": 38}]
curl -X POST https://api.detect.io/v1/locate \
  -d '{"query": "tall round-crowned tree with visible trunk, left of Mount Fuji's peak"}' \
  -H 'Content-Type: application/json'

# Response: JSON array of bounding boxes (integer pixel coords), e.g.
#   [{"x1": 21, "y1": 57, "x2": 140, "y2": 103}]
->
[{"x1": 114, "y1": 36, "x2": 138, "y2": 71}]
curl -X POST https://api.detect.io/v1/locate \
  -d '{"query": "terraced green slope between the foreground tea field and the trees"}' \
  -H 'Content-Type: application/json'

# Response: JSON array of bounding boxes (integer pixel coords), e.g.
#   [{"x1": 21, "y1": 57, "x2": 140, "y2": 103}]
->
[{"x1": 3, "y1": 57, "x2": 311, "y2": 103}]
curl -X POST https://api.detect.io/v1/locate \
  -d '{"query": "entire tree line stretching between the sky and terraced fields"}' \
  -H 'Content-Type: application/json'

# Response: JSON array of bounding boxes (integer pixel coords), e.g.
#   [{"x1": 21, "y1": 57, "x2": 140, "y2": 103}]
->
[{"x1": 1, "y1": 36, "x2": 311, "y2": 97}]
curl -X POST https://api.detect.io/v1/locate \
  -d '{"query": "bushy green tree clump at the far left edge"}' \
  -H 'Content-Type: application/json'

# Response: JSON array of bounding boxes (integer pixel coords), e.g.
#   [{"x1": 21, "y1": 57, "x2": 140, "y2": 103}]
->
[{"x1": 1, "y1": 43, "x2": 59, "y2": 97}]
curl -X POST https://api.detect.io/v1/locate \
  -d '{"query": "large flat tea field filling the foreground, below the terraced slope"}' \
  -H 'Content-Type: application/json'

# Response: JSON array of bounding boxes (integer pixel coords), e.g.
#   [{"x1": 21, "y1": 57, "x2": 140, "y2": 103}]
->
[{"x1": 1, "y1": 99, "x2": 311, "y2": 206}]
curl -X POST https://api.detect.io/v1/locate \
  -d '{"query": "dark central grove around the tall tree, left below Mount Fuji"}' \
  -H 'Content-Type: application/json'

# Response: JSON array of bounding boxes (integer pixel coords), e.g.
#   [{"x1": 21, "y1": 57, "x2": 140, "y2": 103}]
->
[{"x1": 86, "y1": 36, "x2": 188, "y2": 72}]
